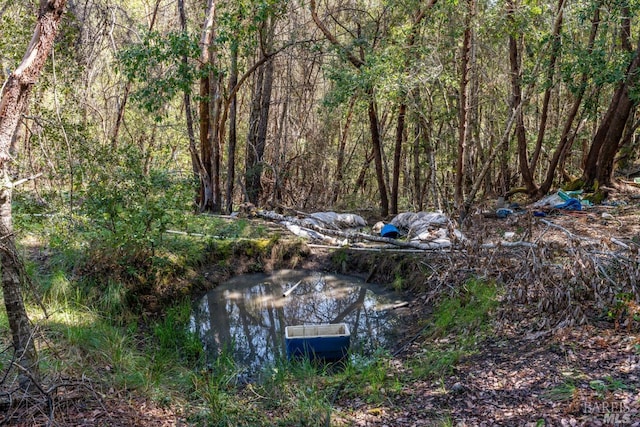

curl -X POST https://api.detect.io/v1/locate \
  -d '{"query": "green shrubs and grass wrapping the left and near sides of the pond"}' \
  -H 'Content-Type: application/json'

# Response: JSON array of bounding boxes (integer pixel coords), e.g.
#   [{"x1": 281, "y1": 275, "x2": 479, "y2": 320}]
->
[{"x1": 0, "y1": 169, "x2": 497, "y2": 426}]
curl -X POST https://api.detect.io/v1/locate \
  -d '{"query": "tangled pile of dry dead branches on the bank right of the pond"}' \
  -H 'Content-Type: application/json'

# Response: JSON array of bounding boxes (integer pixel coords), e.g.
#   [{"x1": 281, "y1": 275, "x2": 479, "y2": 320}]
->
[{"x1": 402, "y1": 214, "x2": 640, "y2": 329}]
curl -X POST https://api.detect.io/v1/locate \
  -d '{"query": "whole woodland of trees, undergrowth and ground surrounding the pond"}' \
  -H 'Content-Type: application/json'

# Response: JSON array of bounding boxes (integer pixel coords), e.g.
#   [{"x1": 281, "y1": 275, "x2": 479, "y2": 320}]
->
[{"x1": 0, "y1": 0, "x2": 640, "y2": 426}]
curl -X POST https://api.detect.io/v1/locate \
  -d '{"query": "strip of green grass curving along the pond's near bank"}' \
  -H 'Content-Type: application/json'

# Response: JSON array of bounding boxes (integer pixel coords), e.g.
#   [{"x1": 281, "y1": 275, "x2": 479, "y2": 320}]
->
[{"x1": 0, "y1": 275, "x2": 497, "y2": 427}]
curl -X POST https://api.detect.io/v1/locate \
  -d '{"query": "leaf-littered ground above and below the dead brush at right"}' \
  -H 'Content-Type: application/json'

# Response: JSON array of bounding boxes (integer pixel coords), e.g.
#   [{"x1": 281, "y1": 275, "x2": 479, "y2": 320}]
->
[{"x1": 324, "y1": 194, "x2": 640, "y2": 427}]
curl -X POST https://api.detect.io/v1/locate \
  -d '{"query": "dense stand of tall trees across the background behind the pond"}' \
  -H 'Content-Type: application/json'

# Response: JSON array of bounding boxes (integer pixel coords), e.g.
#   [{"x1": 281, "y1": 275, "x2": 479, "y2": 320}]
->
[{"x1": 0, "y1": 0, "x2": 638, "y2": 216}]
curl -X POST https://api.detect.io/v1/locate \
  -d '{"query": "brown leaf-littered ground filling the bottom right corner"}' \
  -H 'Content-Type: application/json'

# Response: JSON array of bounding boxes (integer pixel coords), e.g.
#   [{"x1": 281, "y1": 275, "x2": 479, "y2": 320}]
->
[{"x1": 337, "y1": 325, "x2": 640, "y2": 426}]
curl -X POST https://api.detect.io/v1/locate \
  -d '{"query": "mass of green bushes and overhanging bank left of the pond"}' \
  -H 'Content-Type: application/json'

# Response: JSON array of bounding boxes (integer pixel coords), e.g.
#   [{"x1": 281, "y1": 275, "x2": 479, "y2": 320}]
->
[{"x1": 14, "y1": 147, "x2": 270, "y2": 316}]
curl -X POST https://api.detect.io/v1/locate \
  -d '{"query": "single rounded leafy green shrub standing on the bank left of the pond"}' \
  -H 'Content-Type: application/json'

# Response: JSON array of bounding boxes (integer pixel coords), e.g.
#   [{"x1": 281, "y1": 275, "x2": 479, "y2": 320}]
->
[{"x1": 77, "y1": 147, "x2": 191, "y2": 280}]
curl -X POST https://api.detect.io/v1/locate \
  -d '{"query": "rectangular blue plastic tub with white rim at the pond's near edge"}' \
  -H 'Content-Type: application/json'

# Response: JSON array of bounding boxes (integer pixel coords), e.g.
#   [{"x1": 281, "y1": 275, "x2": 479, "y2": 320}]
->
[{"x1": 285, "y1": 323, "x2": 351, "y2": 361}]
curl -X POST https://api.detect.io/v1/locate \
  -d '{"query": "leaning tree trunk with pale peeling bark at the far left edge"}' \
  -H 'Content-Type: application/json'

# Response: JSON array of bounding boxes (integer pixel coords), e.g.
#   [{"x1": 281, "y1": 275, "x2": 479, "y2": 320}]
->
[{"x1": 0, "y1": 0, "x2": 66, "y2": 386}]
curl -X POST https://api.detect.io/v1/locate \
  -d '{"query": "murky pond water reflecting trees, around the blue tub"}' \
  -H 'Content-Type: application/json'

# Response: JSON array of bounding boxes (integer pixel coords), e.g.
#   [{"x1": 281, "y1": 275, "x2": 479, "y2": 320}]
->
[{"x1": 191, "y1": 270, "x2": 404, "y2": 375}]
